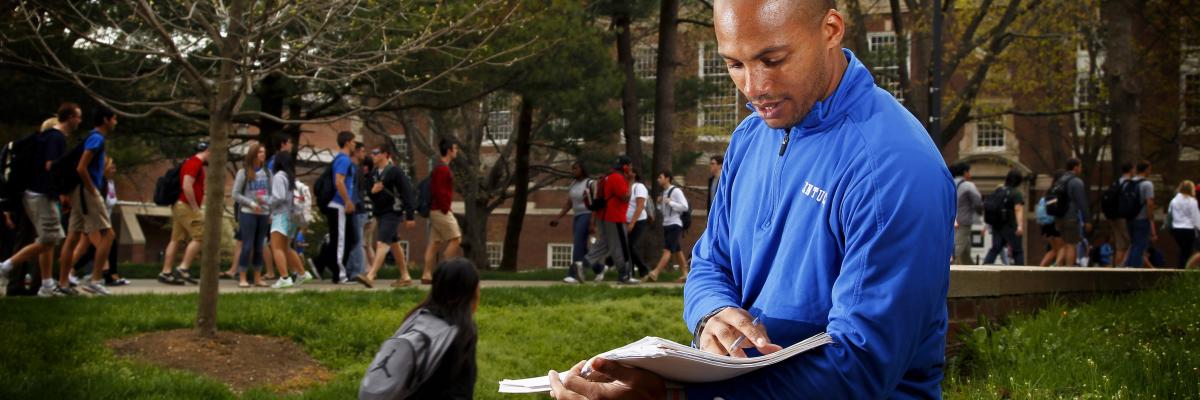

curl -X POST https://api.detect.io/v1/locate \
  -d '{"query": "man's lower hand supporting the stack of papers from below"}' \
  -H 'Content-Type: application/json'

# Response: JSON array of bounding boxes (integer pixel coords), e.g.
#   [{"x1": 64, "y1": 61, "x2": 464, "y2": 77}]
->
[{"x1": 550, "y1": 358, "x2": 667, "y2": 400}]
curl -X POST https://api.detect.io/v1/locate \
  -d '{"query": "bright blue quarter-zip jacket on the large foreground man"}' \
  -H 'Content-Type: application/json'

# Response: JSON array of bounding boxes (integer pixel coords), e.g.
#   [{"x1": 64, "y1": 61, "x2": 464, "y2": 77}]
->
[{"x1": 684, "y1": 50, "x2": 955, "y2": 399}]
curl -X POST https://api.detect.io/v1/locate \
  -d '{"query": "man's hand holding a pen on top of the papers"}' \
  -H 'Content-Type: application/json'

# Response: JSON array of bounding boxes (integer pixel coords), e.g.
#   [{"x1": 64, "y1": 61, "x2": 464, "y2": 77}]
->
[{"x1": 697, "y1": 308, "x2": 784, "y2": 357}]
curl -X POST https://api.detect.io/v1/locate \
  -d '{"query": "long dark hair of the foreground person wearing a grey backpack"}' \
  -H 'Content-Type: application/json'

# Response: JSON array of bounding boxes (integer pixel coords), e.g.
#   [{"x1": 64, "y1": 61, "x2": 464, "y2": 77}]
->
[{"x1": 404, "y1": 257, "x2": 479, "y2": 348}]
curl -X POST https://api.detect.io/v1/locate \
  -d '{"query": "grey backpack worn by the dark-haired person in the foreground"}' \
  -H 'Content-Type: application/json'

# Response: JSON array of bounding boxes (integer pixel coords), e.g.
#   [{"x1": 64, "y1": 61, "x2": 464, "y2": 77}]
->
[{"x1": 359, "y1": 309, "x2": 458, "y2": 400}]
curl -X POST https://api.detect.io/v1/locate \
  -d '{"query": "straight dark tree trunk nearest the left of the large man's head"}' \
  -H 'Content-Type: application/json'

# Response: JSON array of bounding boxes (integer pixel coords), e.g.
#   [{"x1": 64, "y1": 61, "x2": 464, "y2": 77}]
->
[{"x1": 649, "y1": 0, "x2": 682, "y2": 193}]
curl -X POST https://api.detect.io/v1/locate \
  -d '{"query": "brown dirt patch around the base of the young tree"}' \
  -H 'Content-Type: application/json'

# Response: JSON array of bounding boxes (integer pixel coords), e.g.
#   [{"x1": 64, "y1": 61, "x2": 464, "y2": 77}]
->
[{"x1": 107, "y1": 329, "x2": 334, "y2": 393}]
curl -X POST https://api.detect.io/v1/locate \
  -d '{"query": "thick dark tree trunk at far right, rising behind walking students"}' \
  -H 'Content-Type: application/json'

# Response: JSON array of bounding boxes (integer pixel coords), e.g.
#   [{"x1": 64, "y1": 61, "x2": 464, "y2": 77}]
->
[{"x1": 1100, "y1": 0, "x2": 1142, "y2": 166}]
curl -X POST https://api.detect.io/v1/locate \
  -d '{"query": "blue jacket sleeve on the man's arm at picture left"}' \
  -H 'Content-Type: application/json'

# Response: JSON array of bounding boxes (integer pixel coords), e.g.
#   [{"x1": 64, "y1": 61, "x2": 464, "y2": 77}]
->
[{"x1": 683, "y1": 168, "x2": 742, "y2": 336}]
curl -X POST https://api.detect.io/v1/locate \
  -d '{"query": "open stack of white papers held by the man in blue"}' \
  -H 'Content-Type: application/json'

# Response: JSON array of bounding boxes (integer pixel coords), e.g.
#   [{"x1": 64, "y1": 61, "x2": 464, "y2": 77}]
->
[{"x1": 500, "y1": 333, "x2": 833, "y2": 393}]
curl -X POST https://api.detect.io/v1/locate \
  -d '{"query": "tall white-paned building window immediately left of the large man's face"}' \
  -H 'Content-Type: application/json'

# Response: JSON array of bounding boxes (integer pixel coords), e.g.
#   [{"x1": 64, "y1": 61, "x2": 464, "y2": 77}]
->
[{"x1": 697, "y1": 43, "x2": 738, "y2": 132}]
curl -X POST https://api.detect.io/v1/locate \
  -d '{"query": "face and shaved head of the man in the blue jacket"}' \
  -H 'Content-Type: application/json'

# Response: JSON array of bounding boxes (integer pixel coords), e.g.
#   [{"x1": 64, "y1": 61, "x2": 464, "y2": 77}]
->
[{"x1": 713, "y1": 0, "x2": 842, "y2": 129}]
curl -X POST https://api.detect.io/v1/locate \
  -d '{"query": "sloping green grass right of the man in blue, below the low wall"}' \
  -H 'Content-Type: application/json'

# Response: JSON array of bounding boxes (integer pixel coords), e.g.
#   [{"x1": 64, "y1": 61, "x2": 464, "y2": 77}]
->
[{"x1": 943, "y1": 274, "x2": 1200, "y2": 399}]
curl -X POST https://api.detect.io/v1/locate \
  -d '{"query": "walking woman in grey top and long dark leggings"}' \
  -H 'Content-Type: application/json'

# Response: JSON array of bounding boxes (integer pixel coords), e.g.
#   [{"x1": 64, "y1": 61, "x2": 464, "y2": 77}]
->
[{"x1": 233, "y1": 143, "x2": 271, "y2": 287}]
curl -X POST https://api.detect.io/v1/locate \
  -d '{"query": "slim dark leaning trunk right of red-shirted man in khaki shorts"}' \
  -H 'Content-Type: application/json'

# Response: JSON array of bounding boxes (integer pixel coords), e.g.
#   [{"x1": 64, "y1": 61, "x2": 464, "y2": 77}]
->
[{"x1": 500, "y1": 96, "x2": 533, "y2": 271}]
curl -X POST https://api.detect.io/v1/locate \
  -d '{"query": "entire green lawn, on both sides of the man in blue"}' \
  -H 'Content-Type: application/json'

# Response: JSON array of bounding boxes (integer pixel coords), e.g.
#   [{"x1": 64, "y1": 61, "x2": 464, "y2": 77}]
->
[{"x1": 0, "y1": 275, "x2": 1200, "y2": 399}]
